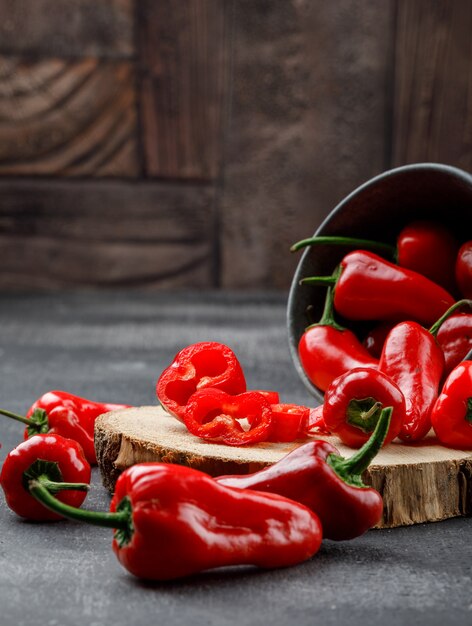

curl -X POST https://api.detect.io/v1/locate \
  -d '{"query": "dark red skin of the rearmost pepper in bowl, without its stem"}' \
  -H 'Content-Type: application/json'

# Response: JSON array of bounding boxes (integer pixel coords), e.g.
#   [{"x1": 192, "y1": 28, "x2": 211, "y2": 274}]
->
[{"x1": 397, "y1": 220, "x2": 459, "y2": 293}]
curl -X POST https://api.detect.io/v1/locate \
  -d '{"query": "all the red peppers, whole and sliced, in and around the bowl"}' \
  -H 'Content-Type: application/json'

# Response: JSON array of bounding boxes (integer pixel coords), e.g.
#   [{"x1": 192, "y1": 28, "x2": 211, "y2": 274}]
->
[{"x1": 0, "y1": 222, "x2": 472, "y2": 580}]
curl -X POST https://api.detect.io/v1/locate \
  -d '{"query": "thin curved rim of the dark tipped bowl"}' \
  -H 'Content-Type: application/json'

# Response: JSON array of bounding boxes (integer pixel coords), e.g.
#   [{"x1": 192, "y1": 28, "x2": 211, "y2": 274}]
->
[{"x1": 286, "y1": 161, "x2": 472, "y2": 403}]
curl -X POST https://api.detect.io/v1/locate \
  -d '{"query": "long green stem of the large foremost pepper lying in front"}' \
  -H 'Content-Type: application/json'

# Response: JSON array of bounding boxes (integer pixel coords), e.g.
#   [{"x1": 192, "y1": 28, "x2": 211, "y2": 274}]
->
[{"x1": 29, "y1": 480, "x2": 129, "y2": 530}]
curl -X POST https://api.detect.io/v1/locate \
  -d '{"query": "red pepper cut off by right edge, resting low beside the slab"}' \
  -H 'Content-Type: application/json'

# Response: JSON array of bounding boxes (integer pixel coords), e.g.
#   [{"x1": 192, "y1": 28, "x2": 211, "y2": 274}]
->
[{"x1": 431, "y1": 361, "x2": 472, "y2": 450}]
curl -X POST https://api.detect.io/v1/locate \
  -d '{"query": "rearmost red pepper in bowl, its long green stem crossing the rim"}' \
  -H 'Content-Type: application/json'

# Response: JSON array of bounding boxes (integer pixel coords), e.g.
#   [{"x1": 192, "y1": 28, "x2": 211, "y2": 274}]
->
[{"x1": 291, "y1": 220, "x2": 459, "y2": 292}]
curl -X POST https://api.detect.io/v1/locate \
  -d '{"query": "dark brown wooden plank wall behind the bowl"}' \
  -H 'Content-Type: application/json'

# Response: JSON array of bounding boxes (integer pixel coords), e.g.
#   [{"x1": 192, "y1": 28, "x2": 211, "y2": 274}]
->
[{"x1": 0, "y1": 0, "x2": 472, "y2": 291}]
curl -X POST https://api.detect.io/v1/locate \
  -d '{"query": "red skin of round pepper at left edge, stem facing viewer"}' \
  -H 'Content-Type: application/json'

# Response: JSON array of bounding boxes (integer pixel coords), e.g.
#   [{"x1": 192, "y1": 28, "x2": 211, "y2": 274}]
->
[{"x1": 0, "y1": 434, "x2": 91, "y2": 521}]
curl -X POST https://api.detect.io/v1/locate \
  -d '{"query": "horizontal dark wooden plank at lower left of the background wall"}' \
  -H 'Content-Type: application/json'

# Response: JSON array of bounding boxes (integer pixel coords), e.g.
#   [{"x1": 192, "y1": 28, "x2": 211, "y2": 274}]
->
[{"x1": 0, "y1": 180, "x2": 214, "y2": 290}]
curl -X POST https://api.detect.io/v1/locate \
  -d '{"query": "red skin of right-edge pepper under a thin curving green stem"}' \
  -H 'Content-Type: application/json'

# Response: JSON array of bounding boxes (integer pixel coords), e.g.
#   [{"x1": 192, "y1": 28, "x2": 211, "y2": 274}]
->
[{"x1": 436, "y1": 313, "x2": 472, "y2": 375}]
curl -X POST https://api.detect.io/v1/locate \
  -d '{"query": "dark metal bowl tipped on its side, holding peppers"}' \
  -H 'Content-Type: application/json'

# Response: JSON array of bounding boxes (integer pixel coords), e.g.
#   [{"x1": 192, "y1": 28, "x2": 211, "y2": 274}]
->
[{"x1": 287, "y1": 163, "x2": 472, "y2": 402}]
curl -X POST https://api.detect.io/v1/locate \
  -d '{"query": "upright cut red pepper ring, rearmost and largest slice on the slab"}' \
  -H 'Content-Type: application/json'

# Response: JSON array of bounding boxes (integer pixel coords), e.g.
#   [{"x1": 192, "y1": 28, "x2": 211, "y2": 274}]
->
[{"x1": 156, "y1": 341, "x2": 246, "y2": 421}]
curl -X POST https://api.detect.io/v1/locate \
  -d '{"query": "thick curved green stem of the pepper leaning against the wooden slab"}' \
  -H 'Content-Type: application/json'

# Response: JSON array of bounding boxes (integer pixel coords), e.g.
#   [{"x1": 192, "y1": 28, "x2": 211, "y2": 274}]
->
[{"x1": 327, "y1": 406, "x2": 393, "y2": 487}]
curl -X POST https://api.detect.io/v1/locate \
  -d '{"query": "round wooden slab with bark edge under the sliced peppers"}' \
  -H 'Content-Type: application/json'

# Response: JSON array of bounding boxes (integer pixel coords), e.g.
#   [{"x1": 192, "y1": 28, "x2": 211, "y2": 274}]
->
[{"x1": 95, "y1": 406, "x2": 472, "y2": 528}]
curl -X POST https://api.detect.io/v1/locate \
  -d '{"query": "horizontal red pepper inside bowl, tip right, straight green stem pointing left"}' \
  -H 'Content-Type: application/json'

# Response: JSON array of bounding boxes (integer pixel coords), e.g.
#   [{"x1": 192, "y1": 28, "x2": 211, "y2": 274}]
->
[{"x1": 301, "y1": 250, "x2": 454, "y2": 325}]
